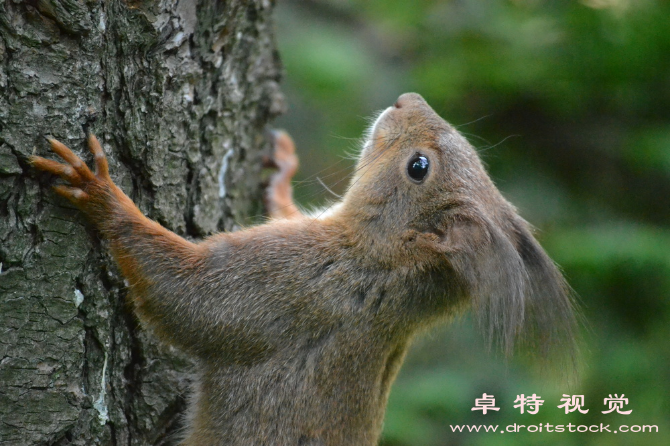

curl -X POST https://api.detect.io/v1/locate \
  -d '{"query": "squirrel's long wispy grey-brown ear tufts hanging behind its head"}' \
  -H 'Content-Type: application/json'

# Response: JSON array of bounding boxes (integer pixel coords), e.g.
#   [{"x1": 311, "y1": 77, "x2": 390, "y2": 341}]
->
[{"x1": 433, "y1": 215, "x2": 576, "y2": 372}]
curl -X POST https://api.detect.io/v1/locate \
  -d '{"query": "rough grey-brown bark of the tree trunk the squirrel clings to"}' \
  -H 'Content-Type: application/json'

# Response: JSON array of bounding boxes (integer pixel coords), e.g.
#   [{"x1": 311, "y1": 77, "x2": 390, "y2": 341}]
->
[{"x1": 0, "y1": 0, "x2": 282, "y2": 445}]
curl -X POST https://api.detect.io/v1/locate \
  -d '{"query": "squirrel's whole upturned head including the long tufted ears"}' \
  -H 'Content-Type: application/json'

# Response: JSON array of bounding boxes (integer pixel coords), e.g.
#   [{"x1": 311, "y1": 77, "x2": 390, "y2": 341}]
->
[{"x1": 342, "y1": 93, "x2": 576, "y2": 372}]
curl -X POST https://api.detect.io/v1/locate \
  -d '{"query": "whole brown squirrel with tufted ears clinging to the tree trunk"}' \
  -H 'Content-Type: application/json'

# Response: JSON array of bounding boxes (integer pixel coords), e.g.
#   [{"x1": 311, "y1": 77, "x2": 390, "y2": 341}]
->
[{"x1": 31, "y1": 93, "x2": 576, "y2": 446}]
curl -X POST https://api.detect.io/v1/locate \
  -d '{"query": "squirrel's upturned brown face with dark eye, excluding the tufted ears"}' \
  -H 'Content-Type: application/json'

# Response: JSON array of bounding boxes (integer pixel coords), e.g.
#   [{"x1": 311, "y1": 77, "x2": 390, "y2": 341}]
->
[{"x1": 344, "y1": 93, "x2": 515, "y2": 232}]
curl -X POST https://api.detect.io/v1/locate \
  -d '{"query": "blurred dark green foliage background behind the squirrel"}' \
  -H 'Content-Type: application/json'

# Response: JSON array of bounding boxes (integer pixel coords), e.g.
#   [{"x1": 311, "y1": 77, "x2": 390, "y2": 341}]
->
[{"x1": 276, "y1": 0, "x2": 670, "y2": 446}]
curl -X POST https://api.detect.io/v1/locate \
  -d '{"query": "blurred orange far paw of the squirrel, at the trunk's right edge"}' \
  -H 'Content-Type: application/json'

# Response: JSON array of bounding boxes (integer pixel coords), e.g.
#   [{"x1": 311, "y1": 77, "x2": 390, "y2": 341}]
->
[{"x1": 263, "y1": 131, "x2": 302, "y2": 218}]
